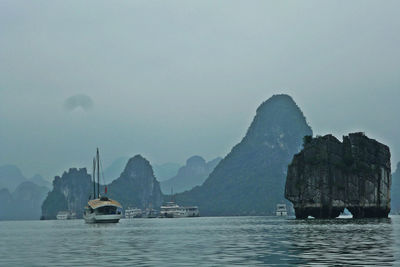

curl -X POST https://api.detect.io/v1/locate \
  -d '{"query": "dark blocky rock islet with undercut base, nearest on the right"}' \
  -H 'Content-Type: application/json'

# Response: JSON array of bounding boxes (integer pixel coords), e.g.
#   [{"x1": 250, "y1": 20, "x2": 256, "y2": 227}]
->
[{"x1": 285, "y1": 133, "x2": 391, "y2": 218}]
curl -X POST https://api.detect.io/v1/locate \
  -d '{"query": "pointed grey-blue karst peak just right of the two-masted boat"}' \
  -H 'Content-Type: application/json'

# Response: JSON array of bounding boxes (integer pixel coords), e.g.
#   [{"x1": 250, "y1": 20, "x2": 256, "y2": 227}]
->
[{"x1": 109, "y1": 155, "x2": 163, "y2": 209}]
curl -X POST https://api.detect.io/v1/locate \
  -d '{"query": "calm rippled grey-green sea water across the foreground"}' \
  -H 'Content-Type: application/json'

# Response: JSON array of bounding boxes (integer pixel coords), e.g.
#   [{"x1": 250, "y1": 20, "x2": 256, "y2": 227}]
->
[{"x1": 0, "y1": 216, "x2": 400, "y2": 266}]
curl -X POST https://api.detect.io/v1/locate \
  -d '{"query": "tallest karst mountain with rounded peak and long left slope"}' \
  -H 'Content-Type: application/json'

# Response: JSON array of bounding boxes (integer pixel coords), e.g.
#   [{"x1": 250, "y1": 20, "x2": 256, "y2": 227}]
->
[{"x1": 176, "y1": 95, "x2": 312, "y2": 216}]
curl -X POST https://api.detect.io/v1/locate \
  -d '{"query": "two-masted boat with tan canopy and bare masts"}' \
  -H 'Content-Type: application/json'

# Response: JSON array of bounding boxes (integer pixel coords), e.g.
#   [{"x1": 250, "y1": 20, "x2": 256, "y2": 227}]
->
[{"x1": 83, "y1": 148, "x2": 122, "y2": 223}]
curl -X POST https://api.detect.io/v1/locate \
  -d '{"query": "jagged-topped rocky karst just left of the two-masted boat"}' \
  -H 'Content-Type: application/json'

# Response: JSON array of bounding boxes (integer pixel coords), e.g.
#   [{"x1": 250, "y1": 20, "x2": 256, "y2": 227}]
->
[{"x1": 42, "y1": 168, "x2": 93, "y2": 219}]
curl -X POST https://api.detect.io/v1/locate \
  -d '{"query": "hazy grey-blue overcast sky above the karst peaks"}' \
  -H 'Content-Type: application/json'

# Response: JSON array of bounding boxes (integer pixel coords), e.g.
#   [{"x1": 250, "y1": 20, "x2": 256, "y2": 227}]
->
[{"x1": 0, "y1": 0, "x2": 400, "y2": 178}]
